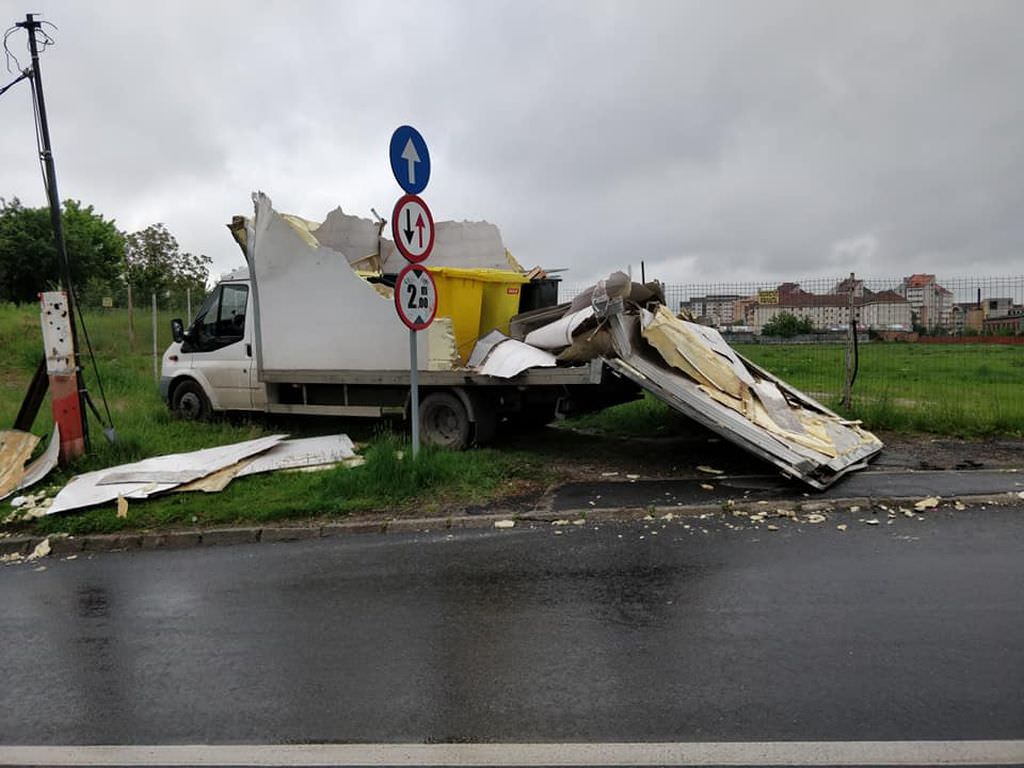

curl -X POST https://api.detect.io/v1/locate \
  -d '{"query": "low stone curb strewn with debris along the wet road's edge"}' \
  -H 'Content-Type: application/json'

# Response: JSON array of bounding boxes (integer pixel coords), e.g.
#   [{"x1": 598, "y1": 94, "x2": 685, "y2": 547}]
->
[{"x1": 0, "y1": 492, "x2": 1024, "y2": 564}]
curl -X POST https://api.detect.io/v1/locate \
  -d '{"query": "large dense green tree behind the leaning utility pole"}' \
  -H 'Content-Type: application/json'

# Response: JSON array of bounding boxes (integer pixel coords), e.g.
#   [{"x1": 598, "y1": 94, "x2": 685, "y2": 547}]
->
[{"x1": 0, "y1": 198, "x2": 124, "y2": 302}]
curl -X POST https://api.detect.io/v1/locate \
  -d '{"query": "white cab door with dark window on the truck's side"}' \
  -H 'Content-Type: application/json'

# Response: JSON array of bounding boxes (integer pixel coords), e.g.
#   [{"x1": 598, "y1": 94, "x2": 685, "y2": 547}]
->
[{"x1": 181, "y1": 283, "x2": 253, "y2": 411}]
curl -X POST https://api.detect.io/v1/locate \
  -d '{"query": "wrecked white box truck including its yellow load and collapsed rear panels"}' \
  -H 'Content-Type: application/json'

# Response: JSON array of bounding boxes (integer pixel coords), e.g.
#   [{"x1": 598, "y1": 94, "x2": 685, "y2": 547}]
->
[{"x1": 160, "y1": 193, "x2": 883, "y2": 488}]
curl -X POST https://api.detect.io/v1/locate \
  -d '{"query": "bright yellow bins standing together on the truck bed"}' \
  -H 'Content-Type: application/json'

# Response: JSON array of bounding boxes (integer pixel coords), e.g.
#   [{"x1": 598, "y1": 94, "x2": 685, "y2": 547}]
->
[{"x1": 427, "y1": 266, "x2": 527, "y2": 362}]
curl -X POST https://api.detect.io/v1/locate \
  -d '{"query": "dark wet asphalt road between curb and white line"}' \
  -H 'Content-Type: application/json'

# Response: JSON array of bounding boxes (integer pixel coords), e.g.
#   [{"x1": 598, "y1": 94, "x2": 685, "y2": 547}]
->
[{"x1": 0, "y1": 508, "x2": 1024, "y2": 744}]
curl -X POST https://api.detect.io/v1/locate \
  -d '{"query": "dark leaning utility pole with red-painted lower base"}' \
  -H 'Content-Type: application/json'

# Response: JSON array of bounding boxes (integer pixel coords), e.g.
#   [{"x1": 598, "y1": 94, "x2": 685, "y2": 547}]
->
[{"x1": 16, "y1": 13, "x2": 89, "y2": 463}]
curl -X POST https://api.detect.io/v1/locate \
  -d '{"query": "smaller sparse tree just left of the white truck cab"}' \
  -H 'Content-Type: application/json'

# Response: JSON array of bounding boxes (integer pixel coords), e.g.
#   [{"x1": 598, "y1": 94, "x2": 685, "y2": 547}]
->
[{"x1": 124, "y1": 222, "x2": 213, "y2": 299}]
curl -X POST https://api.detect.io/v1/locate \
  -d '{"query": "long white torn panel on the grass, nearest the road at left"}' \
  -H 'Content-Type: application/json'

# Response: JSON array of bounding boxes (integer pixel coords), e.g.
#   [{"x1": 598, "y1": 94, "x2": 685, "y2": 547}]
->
[{"x1": 47, "y1": 435, "x2": 286, "y2": 515}]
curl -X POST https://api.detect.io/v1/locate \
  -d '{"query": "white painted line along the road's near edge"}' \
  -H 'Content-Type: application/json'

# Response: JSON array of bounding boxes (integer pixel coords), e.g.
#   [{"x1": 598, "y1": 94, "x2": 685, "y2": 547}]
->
[{"x1": 0, "y1": 740, "x2": 1024, "y2": 766}]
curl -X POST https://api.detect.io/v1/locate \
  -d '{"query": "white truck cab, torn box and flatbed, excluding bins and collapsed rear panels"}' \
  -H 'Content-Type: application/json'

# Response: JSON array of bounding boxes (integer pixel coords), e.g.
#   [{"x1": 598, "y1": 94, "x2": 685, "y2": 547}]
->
[{"x1": 160, "y1": 194, "x2": 640, "y2": 449}]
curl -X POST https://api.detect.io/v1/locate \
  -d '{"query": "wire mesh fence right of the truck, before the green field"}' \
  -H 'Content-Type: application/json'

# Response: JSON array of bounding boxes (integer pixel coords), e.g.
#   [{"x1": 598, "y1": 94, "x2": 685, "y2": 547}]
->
[{"x1": 559, "y1": 274, "x2": 1024, "y2": 433}]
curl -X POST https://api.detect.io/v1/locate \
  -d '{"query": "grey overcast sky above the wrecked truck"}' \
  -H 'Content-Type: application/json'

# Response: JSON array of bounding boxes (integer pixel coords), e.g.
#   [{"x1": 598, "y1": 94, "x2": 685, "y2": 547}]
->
[{"x1": 0, "y1": 0, "x2": 1024, "y2": 283}]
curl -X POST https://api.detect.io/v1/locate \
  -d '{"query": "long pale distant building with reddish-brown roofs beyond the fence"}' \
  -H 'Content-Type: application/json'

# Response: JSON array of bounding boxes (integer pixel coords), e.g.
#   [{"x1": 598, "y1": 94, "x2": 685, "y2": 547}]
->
[{"x1": 750, "y1": 279, "x2": 911, "y2": 333}]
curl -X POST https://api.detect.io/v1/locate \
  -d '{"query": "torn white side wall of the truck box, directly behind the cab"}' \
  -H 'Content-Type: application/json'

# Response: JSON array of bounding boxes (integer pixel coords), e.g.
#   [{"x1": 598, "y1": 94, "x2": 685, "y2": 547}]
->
[{"x1": 247, "y1": 193, "x2": 430, "y2": 374}]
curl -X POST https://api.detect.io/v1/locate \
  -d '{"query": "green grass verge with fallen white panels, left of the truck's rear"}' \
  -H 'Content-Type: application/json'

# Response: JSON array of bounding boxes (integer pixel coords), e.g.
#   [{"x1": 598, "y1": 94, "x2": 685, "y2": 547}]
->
[{"x1": 0, "y1": 305, "x2": 548, "y2": 535}]
